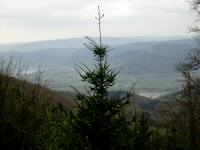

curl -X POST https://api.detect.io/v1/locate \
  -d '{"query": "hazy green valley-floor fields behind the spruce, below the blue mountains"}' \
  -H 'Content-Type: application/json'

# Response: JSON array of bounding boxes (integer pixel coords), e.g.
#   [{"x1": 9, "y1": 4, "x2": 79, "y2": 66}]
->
[{"x1": 38, "y1": 70, "x2": 184, "y2": 93}]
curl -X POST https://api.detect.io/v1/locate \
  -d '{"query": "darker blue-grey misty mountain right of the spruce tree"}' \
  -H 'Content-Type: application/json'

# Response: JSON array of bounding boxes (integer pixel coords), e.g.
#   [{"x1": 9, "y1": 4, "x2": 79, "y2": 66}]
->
[{"x1": 111, "y1": 39, "x2": 197, "y2": 73}]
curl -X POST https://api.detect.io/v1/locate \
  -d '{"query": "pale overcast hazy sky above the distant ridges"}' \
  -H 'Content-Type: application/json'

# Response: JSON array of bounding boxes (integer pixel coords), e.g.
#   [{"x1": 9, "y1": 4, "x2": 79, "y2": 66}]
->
[{"x1": 0, "y1": 0, "x2": 195, "y2": 43}]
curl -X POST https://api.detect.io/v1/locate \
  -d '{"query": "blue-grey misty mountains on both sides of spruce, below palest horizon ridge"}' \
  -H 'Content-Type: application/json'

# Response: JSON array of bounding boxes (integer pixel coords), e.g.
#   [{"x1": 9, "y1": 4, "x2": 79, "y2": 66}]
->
[{"x1": 1, "y1": 39, "x2": 196, "y2": 74}]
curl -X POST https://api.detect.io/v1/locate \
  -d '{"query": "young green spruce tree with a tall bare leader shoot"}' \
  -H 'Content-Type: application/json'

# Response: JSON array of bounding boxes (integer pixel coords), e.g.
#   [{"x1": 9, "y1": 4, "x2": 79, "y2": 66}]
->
[{"x1": 72, "y1": 6, "x2": 130, "y2": 150}]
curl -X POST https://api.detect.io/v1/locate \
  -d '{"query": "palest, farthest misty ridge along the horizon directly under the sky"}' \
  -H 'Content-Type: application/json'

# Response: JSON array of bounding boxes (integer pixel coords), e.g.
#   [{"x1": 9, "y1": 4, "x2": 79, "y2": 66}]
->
[{"x1": 0, "y1": 37, "x2": 191, "y2": 52}]
